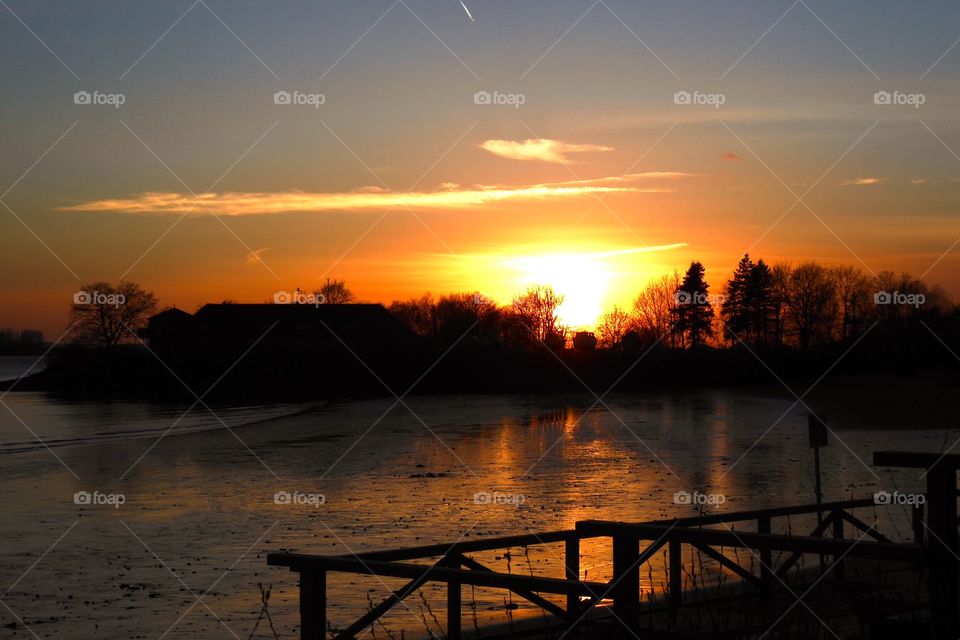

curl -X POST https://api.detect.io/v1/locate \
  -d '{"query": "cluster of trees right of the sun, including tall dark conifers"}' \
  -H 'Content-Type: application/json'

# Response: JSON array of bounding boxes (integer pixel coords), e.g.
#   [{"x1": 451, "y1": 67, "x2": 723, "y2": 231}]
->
[{"x1": 597, "y1": 254, "x2": 953, "y2": 351}]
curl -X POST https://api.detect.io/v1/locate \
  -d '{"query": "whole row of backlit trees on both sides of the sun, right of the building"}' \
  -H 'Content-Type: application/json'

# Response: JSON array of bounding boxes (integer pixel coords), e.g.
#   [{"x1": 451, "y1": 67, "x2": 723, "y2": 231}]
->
[{"x1": 389, "y1": 254, "x2": 954, "y2": 351}]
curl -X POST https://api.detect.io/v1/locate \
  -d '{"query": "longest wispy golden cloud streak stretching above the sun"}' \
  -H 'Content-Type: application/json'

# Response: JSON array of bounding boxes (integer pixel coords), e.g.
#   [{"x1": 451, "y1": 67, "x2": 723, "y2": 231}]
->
[{"x1": 59, "y1": 172, "x2": 680, "y2": 216}]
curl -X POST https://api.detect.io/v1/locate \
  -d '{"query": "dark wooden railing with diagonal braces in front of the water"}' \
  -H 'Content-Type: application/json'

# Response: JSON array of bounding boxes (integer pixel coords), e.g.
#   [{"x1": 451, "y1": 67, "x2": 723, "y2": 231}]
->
[{"x1": 267, "y1": 499, "x2": 927, "y2": 640}]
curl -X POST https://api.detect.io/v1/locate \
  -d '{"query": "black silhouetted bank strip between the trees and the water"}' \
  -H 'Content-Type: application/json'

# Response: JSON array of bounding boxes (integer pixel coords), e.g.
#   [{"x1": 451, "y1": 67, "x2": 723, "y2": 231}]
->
[{"x1": 7, "y1": 338, "x2": 960, "y2": 408}]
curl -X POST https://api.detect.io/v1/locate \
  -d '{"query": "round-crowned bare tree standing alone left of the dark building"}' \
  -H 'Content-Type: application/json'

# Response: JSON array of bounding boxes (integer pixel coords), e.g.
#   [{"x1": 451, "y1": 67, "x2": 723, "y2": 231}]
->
[{"x1": 70, "y1": 280, "x2": 157, "y2": 347}]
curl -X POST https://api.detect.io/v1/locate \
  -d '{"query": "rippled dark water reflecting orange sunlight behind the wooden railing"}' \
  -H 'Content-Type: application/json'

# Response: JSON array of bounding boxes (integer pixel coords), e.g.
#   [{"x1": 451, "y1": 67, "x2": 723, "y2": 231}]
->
[{"x1": 0, "y1": 391, "x2": 944, "y2": 638}]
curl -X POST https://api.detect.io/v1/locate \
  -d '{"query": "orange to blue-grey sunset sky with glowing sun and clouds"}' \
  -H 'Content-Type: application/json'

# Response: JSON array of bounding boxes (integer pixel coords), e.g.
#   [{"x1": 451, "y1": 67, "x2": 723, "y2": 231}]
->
[{"x1": 0, "y1": 0, "x2": 960, "y2": 339}]
